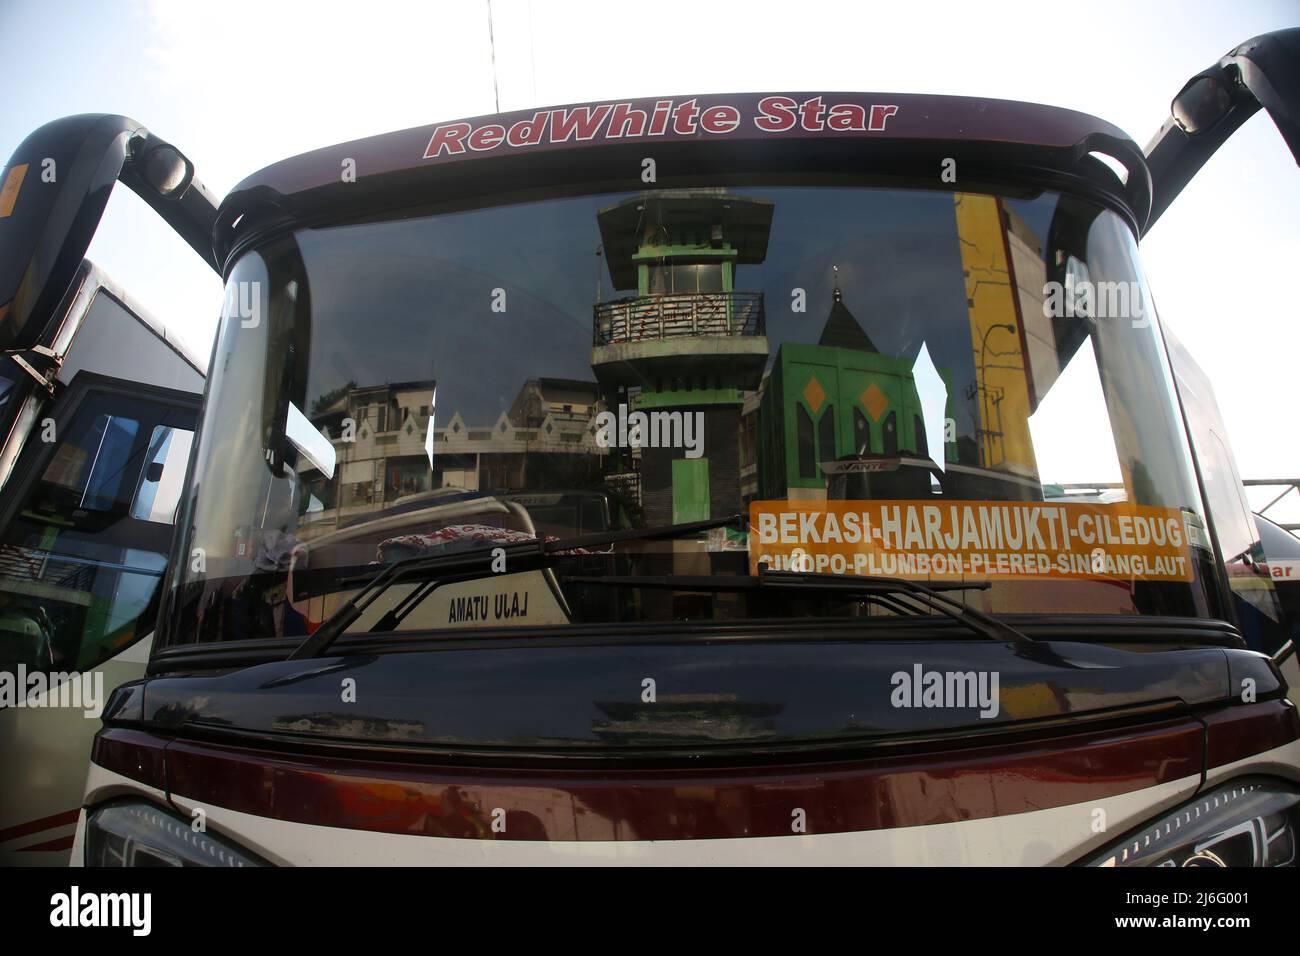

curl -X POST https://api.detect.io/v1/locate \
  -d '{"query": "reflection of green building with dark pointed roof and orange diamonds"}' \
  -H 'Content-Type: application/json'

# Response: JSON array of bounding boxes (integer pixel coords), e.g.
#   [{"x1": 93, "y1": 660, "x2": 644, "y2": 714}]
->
[{"x1": 759, "y1": 277, "x2": 944, "y2": 499}]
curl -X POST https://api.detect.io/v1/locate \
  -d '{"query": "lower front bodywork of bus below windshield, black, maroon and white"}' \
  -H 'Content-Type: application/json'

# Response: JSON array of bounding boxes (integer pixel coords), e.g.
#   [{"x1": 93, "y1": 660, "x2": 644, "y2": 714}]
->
[{"x1": 74, "y1": 634, "x2": 1300, "y2": 865}]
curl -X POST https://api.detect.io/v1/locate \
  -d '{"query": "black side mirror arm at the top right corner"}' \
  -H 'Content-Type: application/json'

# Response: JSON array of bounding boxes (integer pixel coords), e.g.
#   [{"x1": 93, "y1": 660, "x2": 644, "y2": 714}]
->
[{"x1": 1143, "y1": 27, "x2": 1300, "y2": 232}]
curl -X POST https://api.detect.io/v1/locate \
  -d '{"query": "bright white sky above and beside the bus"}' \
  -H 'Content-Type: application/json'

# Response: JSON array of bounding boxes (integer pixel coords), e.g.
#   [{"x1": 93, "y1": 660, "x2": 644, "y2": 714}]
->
[{"x1": 0, "y1": 0, "x2": 1300, "y2": 520}]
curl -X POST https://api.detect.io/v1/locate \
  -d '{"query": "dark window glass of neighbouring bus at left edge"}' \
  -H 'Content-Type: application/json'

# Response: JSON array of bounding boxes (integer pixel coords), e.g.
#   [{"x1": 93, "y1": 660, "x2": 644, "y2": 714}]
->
[{"x1": 0, "y1": 392, "x2": 194, "y2": 671}]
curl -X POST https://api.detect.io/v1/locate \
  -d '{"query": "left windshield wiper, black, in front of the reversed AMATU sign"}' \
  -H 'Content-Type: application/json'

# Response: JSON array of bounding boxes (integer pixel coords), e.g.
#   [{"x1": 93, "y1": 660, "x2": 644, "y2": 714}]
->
[{"x1": 286, "y1": 515, "x2": 745, "y2": 661}]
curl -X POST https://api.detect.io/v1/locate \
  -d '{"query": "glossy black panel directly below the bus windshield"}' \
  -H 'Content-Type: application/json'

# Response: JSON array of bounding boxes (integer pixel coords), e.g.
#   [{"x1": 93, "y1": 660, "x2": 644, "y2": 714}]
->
[{"x1": 104, "y1": 639, "x2": 1286, "y2": 757}]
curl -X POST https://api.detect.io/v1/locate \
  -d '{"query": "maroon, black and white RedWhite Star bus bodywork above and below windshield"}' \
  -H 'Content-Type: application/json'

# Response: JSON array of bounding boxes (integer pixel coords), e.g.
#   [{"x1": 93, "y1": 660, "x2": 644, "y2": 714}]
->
[{"x1": 74, "y1": 65, "x2": 1300, "y2": 865}]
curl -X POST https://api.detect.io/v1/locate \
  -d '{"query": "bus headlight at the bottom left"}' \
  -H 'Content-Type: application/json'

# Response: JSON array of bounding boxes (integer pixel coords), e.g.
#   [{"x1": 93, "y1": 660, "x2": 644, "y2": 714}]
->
[{"x1": 86, "y1": 800, "x2": 267, "y2": 866}]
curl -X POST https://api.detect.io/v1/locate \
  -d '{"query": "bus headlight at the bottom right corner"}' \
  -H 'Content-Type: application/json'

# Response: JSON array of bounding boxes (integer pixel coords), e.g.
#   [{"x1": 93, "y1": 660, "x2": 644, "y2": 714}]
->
[{"x1": 1083, "y1": 778, "x2": 1300, "y2": 866}]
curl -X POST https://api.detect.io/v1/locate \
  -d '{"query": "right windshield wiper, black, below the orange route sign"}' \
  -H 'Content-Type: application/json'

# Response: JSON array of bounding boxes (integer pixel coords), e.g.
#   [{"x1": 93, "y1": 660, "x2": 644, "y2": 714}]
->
[{"x1": 564, "y1": 571, "x2": 1032, "y2": 641}]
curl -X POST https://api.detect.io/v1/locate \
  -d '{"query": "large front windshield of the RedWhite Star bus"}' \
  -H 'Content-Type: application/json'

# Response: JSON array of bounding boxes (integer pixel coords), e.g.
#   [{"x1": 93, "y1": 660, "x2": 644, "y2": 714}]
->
[{"x1": 159, "y1": 186, "x2": 1219, "y2": 643}]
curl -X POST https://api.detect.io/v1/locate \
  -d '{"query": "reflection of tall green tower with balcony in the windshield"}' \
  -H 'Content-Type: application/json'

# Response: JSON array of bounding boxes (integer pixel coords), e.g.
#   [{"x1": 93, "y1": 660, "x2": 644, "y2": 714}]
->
[{"x1": 592, "y1": 189, "x2": 774, "y2": 524}]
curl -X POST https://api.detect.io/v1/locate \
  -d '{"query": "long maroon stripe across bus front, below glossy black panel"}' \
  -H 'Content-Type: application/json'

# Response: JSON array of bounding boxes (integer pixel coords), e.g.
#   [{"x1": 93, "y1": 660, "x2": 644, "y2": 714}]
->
[{"x1": 166, "y1": 719, "x2": 1204, "y2": 840}]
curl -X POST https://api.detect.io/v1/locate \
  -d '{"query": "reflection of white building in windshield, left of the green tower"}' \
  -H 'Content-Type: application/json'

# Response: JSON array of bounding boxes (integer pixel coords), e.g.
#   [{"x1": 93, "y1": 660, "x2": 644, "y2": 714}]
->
[{"x1": 304, "y1": 378, "x2": 606, "y2": 522}]
